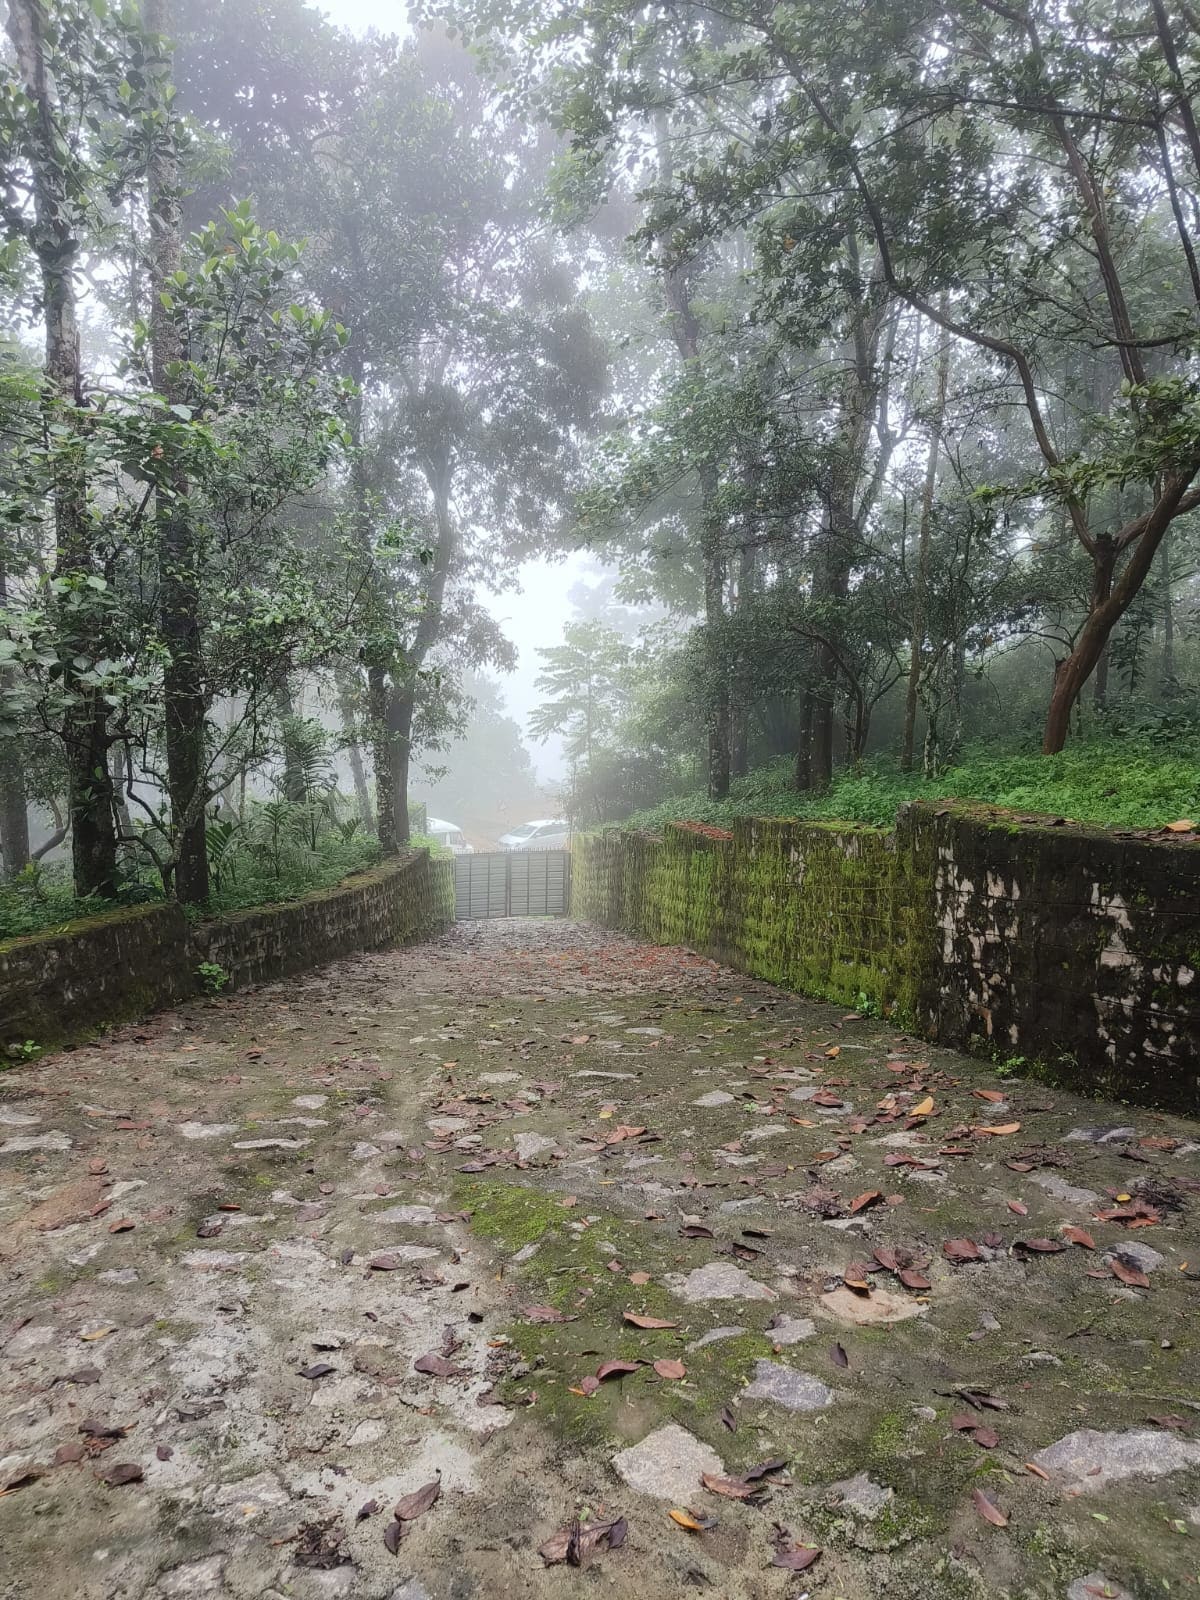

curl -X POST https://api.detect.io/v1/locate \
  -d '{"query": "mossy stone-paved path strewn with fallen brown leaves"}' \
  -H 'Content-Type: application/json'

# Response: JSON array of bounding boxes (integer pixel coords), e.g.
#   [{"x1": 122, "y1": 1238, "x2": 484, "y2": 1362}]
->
[{"x1": 0, "y1": 922, "x2": 1200, "y2": 1600}]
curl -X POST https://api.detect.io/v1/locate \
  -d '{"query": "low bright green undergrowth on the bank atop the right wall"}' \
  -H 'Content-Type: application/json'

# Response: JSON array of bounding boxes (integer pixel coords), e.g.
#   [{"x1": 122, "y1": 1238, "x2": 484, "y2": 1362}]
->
[{"x1": 618, "y1": 738, "x2": 1200, "y2": 832}]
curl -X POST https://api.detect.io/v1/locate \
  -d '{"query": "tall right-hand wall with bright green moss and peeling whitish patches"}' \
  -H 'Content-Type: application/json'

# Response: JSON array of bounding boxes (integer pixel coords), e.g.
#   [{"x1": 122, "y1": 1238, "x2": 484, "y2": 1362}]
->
[{"x1": 571, "y1": 805, "x2": 1200, "y2": 1110}]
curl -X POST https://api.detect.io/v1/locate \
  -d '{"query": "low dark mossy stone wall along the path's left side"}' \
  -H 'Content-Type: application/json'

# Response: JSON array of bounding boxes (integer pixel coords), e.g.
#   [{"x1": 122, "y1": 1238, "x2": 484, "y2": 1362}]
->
[{"x1": 0, "y1": 850, "x2": 454, "y2": 1046}]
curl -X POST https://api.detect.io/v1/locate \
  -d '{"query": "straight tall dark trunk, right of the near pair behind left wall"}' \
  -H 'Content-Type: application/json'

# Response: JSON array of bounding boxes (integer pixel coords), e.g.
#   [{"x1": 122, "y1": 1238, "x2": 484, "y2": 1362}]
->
[{"x1": 142, "y1": 0, "x2": 210, "y2": 906}]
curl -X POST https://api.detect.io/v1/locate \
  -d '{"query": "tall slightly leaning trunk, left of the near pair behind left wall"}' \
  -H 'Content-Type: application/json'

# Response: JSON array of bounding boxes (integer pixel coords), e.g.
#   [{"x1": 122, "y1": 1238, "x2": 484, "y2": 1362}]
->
[{"x1": 8, "y1": 0, "x2": 117, "y2": 899}]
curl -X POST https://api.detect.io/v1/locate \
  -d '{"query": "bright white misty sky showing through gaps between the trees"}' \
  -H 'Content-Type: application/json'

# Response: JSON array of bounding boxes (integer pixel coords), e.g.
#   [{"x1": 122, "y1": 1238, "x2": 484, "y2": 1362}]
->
[{"x1": 317, "y1": 0, "x2": 594, "y2": 781}]
